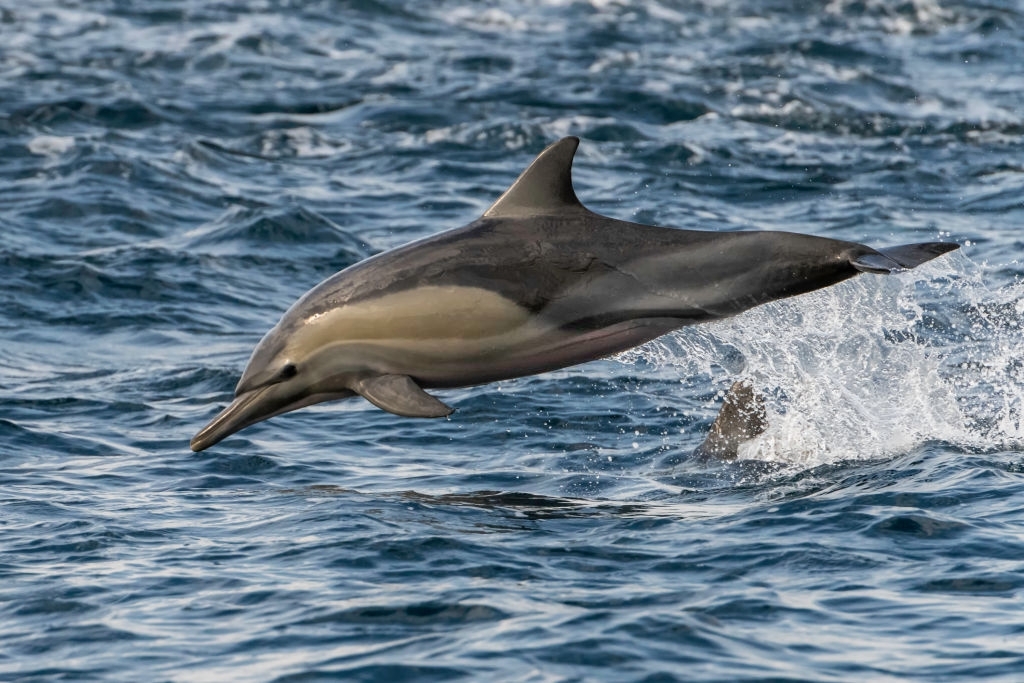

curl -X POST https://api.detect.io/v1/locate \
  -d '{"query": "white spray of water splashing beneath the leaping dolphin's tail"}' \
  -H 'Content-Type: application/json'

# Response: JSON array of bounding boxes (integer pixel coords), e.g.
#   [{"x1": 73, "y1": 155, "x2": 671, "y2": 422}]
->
[{"x1": 621, "y1": 253, "x2": 1024, "y2": 467}]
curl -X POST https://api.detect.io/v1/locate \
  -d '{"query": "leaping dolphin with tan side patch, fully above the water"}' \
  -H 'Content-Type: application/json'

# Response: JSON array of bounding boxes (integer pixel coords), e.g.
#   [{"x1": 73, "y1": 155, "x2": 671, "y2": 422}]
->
[{"x1": 191, "y1": 137, "x2": 958, "y2": 452}]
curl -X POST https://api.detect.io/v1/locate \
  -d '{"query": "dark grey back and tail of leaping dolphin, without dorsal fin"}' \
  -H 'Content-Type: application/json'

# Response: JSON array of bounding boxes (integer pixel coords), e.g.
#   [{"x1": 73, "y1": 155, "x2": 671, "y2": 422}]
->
[{"x1": 286, "y1": 214, "x2": 949, "y2": 330}]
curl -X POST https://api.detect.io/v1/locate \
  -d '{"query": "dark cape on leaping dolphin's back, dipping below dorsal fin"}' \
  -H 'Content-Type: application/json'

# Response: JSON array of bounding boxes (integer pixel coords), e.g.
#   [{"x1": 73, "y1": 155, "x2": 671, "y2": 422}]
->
[{"x1": 295, "y1": 216, "x2": 740, "y2": 321}]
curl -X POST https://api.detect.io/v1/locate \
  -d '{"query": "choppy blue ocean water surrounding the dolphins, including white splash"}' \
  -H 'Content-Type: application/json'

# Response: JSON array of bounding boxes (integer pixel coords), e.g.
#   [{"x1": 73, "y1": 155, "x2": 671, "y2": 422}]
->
[{"x1": 0, "y1": 0, "x2": 1024, "y2": 682}]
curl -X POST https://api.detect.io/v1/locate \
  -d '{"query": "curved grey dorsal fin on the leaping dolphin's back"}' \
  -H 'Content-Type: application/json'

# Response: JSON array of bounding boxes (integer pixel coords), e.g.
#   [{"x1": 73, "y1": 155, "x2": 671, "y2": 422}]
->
[{"x1": 483, "y1": 137, "x2": 586, "y2": 218}]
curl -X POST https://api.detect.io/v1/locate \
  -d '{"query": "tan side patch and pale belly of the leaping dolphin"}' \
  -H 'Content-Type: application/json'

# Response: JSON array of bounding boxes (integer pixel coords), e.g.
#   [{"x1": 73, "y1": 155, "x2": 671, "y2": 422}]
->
[{"x1": 293, "y1": 286, "x2": 679, "y2": 387}]
